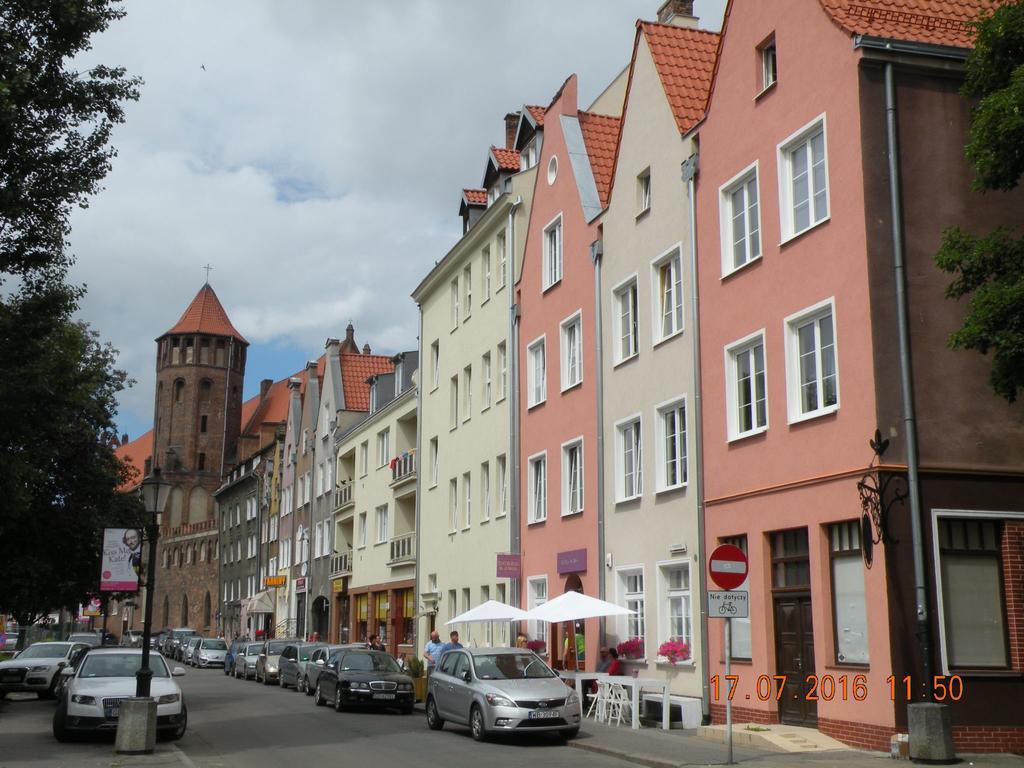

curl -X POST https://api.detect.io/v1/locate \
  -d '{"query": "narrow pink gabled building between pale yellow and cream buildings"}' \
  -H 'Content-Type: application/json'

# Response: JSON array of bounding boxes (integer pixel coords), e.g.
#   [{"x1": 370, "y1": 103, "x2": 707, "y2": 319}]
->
[{"x1": 516, "y1": 75, "x2": 622, "y2": 667}]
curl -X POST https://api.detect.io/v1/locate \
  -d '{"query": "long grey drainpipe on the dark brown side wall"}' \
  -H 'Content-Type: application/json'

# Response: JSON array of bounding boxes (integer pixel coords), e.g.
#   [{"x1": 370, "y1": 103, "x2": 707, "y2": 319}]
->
[{"x1": 885, "y1": 63, "x2": 932, "y2": 690}]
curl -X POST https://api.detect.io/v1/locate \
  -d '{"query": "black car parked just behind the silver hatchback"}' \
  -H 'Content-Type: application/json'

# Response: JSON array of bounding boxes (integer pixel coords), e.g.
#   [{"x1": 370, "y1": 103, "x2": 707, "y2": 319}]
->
[{"x1": 313, "y1": 649, "x2": 415, "y2": 715}]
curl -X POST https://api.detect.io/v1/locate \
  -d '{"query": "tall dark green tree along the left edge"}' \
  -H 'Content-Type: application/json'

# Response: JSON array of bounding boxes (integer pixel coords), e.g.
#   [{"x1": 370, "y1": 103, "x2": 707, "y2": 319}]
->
[{"x1": 0, "y1": 0, "x2": 140, "y2": 651}]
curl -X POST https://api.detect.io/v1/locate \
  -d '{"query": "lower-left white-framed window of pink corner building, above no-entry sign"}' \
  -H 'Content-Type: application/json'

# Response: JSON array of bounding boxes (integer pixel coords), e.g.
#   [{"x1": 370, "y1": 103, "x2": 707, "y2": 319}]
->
[{"x1": 725, "y1": 330, "x2": 768, "y2": 440}]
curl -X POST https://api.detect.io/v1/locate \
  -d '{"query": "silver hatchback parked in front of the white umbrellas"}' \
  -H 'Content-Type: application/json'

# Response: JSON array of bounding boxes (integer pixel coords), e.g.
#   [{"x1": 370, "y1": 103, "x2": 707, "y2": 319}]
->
[{"x1": 427, "y1": 648, "x2": 583, "y2": 741}]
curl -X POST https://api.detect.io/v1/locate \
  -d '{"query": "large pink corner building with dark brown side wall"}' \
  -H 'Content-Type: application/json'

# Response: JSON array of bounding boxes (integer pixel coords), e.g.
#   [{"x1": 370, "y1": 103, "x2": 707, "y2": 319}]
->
[{"x1": 696, "y1": 0, "x2": 1024, "y2": 751}]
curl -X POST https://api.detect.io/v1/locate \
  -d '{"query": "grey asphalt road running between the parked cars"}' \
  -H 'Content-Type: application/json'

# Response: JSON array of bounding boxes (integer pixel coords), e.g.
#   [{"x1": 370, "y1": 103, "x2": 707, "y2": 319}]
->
[{"x1": 0, "y1": 669, "x2": 633, "y2": 768}]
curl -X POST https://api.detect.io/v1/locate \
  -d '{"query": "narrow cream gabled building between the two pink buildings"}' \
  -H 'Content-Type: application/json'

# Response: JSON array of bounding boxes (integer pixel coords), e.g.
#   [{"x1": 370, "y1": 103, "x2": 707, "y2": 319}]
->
[{"x1": 599, "y1": 10, "x2": 717, "y2": 722}]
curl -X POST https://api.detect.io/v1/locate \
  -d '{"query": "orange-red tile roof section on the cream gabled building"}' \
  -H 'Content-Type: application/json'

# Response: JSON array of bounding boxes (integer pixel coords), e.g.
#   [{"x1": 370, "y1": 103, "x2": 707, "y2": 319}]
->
[{"x1": 643, "y1": 22, "x2": 724, "y2": 133}]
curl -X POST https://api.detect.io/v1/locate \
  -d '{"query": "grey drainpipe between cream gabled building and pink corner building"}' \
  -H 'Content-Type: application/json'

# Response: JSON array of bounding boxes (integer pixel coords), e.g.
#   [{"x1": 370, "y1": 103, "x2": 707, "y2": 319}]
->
[{"x1": 682, "y1": 153, "x2": 711, "y2": 724}]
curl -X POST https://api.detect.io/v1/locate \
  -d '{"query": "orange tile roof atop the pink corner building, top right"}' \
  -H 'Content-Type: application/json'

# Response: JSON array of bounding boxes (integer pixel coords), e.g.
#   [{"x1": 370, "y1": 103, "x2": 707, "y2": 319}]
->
[{"x1": 820, "y1": 0, "x2": 1002, "y2": 48}]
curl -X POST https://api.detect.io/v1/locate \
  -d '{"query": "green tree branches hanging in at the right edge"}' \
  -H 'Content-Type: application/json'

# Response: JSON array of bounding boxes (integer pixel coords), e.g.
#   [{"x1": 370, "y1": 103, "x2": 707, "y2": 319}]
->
[{"x1": 935, "y1": 0, "x2": 1024, "y2": 402}]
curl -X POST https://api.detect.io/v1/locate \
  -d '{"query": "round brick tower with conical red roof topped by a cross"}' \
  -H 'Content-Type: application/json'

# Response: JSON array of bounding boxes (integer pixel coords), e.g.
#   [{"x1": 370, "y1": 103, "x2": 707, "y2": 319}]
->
[{"x1": 153, "y1": 283, "x2": 249, "y2": 634}]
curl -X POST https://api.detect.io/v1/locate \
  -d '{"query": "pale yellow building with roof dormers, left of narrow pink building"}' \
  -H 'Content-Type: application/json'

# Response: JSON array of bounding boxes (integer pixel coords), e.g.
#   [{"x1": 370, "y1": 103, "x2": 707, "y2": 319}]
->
[{"x1": 413, "y1": 128, "x2": 541, "y2": 657}]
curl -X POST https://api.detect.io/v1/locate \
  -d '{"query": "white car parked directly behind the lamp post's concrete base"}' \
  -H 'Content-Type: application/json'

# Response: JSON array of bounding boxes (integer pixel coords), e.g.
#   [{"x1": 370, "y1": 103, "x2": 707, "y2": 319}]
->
[{"x1": 53, "y1": 648, "x2": 188, "y2": 741}]
